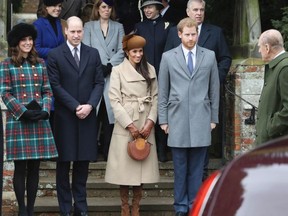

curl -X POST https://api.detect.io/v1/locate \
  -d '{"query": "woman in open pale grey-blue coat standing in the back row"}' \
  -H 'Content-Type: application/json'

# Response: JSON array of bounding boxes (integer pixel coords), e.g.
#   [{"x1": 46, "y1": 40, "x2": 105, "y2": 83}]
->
[{"x1": 83, "y1": 0, "x2": 124, "y2": 160}]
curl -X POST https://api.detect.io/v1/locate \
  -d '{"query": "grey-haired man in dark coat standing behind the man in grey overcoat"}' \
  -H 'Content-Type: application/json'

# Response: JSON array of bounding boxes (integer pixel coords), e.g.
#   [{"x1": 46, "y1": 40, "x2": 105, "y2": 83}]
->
[{"x1": 165, "y1": 0, "x2": 232, "y2": 180}]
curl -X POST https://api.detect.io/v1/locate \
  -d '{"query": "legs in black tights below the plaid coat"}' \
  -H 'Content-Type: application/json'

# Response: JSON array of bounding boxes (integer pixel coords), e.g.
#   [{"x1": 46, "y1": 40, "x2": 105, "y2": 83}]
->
[{"x1": 13, "y1": 160, "x2": 40, "y2": 216}]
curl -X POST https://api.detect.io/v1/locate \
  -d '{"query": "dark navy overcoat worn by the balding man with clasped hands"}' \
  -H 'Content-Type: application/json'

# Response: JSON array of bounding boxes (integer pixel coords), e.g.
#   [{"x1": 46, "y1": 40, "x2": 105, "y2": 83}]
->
[{"x1": 47, "y1": 43, "x2": 104, "y2": 161}]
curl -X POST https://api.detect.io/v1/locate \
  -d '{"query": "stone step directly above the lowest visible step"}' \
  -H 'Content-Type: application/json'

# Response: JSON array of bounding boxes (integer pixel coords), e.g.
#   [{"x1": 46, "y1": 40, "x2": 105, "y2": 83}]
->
[{"x1": 38, "y1": 176, "x2": 173, "y2": 198}]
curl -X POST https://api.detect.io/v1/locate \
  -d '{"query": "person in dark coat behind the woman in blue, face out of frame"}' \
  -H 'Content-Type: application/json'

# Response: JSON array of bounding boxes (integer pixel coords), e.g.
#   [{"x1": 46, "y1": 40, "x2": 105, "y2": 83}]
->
[{"x1": 37, "y1": 0, "x2": 87, "y2": 20}]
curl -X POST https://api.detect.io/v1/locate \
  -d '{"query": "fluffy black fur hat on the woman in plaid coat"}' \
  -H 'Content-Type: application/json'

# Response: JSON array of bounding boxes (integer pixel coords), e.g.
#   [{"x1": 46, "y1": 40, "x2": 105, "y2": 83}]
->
[{"x1": 7, "y1": 23, "x2": 37, "y2": 47}]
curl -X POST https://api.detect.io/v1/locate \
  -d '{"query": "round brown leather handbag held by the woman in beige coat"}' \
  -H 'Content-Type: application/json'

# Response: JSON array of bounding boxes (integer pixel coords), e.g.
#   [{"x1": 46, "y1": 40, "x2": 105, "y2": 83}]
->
[{"x1": 127, "y1": 137, "x2": 151, "y2": 161}]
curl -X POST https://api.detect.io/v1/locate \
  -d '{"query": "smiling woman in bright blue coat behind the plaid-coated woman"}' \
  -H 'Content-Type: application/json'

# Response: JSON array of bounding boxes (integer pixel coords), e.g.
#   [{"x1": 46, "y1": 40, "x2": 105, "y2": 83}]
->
[{"x1": 33, "y1": 0, "x2": 64, "y2": 130}]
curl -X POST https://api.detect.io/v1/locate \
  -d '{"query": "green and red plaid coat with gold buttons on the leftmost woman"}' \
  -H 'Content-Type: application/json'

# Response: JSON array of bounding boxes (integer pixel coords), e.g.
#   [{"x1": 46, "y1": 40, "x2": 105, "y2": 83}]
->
[{"x1": 0, "y1": 58, "x2": 58, "y2": 160}]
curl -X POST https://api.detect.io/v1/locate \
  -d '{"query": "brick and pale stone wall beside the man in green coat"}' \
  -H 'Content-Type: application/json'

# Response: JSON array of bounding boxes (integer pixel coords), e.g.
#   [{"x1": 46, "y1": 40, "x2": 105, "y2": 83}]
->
[{"x1": 224, "y1": 59, "x2": 264, "y2": 160}]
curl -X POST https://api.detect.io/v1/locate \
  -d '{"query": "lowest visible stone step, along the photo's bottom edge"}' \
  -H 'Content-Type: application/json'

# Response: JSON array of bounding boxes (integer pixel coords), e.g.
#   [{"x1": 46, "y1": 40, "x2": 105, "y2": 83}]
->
[{"x1": 35, "y1": 197, "x2": 175, "y2": 216}]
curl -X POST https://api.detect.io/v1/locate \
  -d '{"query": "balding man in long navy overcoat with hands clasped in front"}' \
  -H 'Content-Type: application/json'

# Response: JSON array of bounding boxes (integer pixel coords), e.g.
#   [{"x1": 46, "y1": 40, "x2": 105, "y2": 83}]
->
[{"x1": 47, "y1": 16, "x2": 104, "y2": 216}]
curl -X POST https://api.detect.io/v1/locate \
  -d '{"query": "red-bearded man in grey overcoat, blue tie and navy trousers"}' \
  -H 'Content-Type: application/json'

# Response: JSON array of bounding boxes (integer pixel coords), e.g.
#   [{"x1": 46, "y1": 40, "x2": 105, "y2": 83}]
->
[{"x1": 158, "y1": 17, "x2": 220, "y2": 216}]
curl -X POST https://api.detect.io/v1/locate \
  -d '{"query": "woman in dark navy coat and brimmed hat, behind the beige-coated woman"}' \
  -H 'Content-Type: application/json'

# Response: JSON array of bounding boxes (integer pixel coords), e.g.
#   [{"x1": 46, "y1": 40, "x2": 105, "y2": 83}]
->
[{"x1": 135, "y1": 0, "x2": 170, "y2": 162}]
